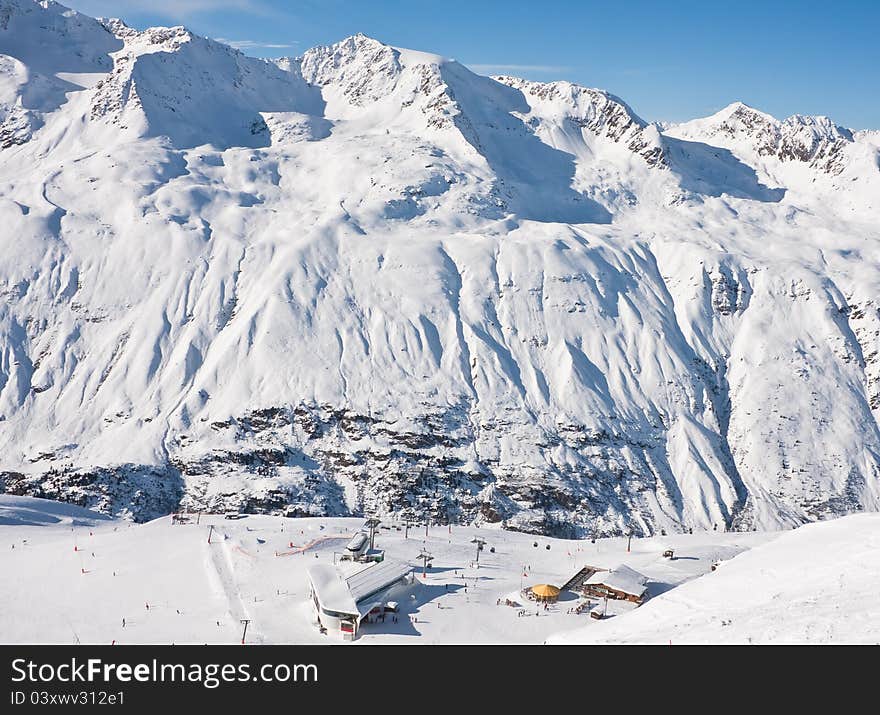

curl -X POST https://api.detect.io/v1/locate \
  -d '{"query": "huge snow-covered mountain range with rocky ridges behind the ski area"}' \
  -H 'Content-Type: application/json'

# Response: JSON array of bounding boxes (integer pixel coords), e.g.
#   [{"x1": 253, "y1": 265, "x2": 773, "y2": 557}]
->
[{"x1": 0, "y1": 0, "x2": 880, "y2": 535}]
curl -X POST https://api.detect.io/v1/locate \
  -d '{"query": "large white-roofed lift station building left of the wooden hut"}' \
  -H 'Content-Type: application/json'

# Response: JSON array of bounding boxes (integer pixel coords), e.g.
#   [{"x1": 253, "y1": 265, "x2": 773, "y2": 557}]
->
[{"x1": 308, "y1": 558, "x2": 413, "y2": 638}]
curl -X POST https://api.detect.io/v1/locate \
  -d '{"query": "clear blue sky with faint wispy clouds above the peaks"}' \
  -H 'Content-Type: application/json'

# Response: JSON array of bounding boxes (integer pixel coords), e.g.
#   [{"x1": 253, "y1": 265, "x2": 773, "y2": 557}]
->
[{"x1": 62, "y1": 0, "x2": 880, "y2": 129}]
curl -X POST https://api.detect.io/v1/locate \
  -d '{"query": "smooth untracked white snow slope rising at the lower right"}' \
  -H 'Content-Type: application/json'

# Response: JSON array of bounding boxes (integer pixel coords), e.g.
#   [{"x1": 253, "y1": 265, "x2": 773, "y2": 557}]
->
[{"x1": 549, "y1": 514, "x2": 880, "y2": 645}]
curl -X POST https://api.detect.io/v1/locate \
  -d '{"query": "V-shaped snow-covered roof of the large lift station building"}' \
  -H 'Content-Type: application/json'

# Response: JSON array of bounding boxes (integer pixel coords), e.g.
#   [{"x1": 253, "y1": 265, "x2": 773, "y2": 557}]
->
[{"x1": 309, "y1": 559, "x2": 412, "y2": 615}]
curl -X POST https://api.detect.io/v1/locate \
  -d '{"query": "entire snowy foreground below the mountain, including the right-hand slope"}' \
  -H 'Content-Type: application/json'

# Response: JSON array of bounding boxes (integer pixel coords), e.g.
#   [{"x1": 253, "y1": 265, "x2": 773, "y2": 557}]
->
[{"x1": 0, "y1": 496, "x2": 880, "y2": 644}]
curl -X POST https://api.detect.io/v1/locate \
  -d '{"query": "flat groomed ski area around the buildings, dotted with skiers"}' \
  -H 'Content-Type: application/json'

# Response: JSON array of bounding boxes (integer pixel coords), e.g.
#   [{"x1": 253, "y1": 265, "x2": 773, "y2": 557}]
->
[{"x1": 0, "y1": 495, "x2": 776, "y2": 644}]
